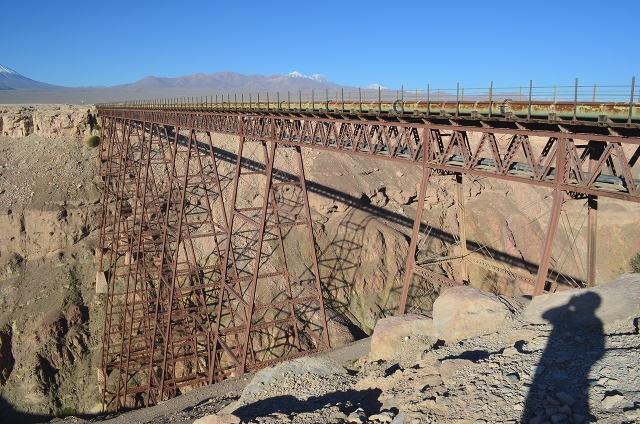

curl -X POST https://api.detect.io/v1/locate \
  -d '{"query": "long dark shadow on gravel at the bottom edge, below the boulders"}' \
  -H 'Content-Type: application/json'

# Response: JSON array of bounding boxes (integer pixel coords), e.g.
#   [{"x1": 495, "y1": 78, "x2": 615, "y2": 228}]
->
[{"x1": 233, "y1": 389, "x2": 382, "y2": 422}]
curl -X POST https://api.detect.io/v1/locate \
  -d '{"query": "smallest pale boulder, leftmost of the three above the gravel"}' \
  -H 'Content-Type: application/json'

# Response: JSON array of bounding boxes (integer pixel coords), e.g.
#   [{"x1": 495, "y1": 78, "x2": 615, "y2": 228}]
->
[{"x1": 369, "y1": 314, "x2": 433, "y2": 361}]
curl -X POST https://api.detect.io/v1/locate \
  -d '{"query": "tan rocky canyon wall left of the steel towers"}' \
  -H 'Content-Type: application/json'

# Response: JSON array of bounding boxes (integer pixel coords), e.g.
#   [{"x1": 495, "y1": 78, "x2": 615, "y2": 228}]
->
[{"x1": 0, "y1": 106, "x2": 102, "y2": 416}]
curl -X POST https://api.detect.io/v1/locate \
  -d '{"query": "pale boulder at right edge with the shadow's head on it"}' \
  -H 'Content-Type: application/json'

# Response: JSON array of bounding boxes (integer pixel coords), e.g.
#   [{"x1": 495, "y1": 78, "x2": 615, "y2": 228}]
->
[{"x1": 523, "y1": 274, "x2": 640, "y2": 333}]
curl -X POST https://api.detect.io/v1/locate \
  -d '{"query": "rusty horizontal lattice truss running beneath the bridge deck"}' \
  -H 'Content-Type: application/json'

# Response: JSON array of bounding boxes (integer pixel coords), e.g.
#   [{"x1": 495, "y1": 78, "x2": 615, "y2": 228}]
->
[{"x1": 103, "y1": 109, "x2": 640, "y2": 202}]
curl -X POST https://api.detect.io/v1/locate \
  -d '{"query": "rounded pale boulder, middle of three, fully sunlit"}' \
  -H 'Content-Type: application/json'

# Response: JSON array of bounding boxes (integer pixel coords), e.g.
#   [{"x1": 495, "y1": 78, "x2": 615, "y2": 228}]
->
[{"x1": 433, "y1": 286, "x2": 522, "y2": 342}]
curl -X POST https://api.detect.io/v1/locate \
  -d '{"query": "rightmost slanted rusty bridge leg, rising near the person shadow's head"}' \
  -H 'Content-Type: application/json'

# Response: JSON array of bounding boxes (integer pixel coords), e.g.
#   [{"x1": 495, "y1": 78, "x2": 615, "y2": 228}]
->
[{"x1": 533, "y1": 135, "x2": 567, "y2": 296}]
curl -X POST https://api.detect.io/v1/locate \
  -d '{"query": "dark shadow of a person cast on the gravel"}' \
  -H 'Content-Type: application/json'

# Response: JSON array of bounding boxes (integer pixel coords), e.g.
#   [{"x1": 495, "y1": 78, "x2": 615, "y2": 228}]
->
[{"x1": 521, "y1": 292, "x2": 605, "y2": 424}]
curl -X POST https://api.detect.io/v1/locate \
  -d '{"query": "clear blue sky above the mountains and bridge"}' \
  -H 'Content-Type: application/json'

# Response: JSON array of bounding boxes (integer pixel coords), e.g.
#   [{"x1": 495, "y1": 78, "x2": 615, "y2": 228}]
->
[{"x1": 0, "y1": 0, "x2": 640, "y2": 88}]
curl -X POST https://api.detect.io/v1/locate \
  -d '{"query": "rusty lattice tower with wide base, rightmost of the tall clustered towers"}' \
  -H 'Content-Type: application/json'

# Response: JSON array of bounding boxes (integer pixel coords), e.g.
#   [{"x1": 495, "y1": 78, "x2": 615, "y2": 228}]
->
[{"x1": 216, "y1": 138, "x2": 329, "y2": 373}]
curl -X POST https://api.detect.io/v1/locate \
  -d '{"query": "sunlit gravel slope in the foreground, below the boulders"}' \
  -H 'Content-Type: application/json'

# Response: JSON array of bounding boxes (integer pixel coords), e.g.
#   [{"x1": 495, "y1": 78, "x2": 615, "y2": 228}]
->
[{"x1": 51, "y1": 312, "x2": 640, "y2": 424}]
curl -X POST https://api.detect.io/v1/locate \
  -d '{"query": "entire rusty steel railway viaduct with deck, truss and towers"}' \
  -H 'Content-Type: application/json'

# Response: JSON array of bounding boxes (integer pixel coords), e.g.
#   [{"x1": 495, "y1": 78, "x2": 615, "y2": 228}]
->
[{"x1": 97, "y1": 88, "x2": 640, "y2": 410}]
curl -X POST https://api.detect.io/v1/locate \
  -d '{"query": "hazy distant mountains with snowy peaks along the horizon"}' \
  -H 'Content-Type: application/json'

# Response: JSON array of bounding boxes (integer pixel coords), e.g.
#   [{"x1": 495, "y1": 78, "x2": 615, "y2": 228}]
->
[{"x1": 0, "y1": 65, "x2": 384, "y2": 91}]
